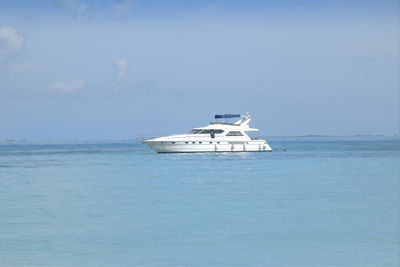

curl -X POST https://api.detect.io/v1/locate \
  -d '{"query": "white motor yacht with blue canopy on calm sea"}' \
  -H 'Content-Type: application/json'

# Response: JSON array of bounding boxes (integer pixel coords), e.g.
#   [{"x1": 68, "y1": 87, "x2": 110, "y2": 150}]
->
[{"x1": 143, "y1": 113, "x2": 272, "y2": 153}]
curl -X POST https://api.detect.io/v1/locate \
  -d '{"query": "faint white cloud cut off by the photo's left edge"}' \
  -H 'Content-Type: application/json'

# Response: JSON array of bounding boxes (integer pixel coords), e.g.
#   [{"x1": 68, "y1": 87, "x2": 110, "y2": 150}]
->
[{"x1": 0, "y1": 26, "x2": 24, "y2": 60}]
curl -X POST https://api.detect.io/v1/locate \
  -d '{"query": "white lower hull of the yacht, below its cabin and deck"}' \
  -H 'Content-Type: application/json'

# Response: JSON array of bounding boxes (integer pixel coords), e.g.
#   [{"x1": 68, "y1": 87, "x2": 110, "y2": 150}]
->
[{"x1": 144, "y1": 140, "x2": 272, "y2": 153}]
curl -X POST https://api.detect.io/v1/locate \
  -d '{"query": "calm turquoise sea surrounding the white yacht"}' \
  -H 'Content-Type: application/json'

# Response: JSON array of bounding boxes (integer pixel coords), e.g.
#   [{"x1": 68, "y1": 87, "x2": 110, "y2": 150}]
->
[{"x1": 0, "y1": 137, "x2": 400, "y2": 267}]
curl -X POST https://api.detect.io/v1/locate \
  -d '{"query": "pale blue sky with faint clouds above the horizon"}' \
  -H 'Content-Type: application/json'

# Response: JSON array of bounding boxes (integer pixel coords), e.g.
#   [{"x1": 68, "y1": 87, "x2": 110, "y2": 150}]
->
[{"x1": 0, "y1": 0, "x2": 400, "y2": 141}]
